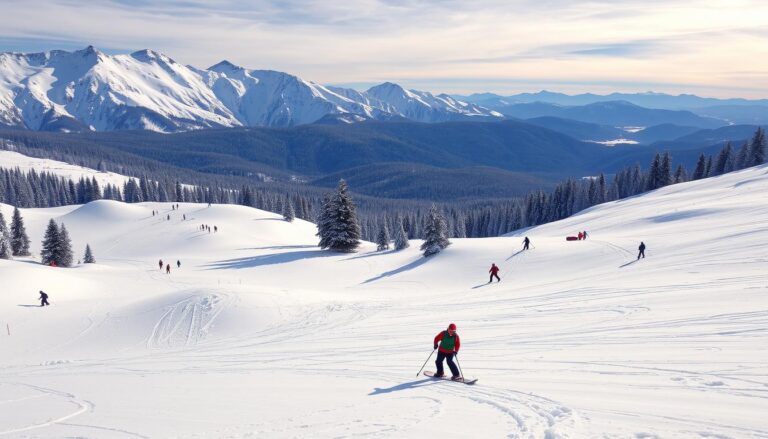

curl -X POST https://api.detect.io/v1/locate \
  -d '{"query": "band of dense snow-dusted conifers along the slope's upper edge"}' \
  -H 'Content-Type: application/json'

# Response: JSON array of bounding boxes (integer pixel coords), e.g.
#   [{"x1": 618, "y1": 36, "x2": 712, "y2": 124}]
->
[{"x1": 0, "y1": 128, "x2": 766, "y2": 251}]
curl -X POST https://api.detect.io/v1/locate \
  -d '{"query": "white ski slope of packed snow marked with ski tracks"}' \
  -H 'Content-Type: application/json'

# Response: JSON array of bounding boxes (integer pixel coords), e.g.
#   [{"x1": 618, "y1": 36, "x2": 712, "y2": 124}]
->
[{"x1": 0, "y1": 166, "x2": 768, "y2": 438}]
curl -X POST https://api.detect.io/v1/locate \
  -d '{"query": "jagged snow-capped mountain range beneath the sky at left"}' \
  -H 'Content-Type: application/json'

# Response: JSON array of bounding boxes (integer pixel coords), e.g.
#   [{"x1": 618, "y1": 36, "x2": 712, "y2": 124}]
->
[{"x1": 0, "y1": 46, "x2": 502, "y2": 132}]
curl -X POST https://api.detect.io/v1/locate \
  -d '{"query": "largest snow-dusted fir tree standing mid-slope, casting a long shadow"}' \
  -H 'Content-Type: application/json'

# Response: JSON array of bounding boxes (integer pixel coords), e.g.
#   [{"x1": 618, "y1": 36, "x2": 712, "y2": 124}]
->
[{"x1": 317, "y1": 180, "x2": 360, "y2": 252}]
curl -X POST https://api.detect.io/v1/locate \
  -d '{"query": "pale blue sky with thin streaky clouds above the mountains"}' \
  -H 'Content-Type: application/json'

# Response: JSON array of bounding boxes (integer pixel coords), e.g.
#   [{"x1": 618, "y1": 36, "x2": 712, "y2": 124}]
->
[{"x1": 0, "y1": 0, "x2": 768, "y2": 98}]
